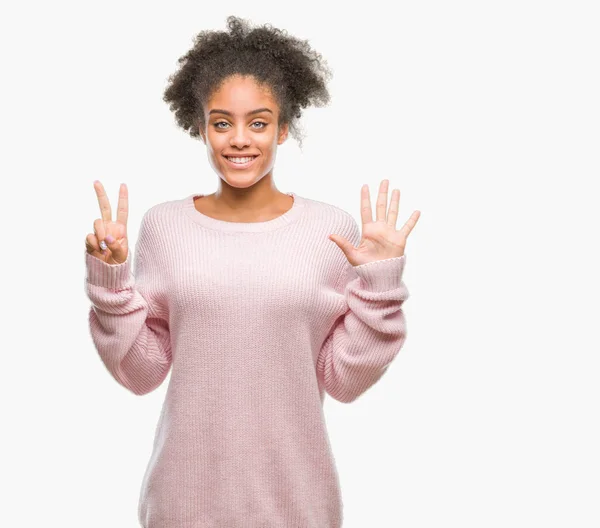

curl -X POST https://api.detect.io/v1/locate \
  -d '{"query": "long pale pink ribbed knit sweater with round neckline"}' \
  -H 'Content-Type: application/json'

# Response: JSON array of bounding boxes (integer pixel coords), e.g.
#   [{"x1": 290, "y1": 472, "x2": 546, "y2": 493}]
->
[{"x1": 85, "y1": 192, "x2": 408, "y2": 528}]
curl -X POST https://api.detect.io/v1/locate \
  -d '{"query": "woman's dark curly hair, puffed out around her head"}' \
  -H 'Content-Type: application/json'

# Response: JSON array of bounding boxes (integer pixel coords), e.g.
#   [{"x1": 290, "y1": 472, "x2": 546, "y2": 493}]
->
[{"x1": 163, "y1": 16, "x2": 332, "y2": 148}]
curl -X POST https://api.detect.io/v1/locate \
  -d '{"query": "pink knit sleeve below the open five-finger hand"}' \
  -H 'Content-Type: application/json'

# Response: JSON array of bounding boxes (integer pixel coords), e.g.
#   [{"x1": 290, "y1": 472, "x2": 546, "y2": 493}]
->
[{"x1": 317, "y1": 217, "x2": 409, "y2": 403}]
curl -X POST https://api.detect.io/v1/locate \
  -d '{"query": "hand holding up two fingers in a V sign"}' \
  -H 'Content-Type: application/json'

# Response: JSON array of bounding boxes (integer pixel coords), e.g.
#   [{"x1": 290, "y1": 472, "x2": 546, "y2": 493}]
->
[{"x1": 85, "y1": 180, "x2": 129, "y2": 264}]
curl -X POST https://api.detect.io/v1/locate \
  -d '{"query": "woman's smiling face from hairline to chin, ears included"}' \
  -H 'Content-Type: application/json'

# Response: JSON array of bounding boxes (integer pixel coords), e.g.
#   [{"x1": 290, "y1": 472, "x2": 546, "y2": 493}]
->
[{"x1": 200, "y1": 75, "x2": 288, "y2": 187}]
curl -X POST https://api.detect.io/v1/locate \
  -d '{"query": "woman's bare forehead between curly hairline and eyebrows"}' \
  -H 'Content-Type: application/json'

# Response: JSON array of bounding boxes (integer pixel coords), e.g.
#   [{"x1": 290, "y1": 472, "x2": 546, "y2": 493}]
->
[{"x1": 206, "y1": 75, "x2": 278, "y2": 115}]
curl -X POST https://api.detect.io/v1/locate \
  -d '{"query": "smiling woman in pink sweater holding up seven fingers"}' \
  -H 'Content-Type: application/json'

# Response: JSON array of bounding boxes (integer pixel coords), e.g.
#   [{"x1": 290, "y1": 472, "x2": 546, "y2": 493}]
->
[{"x1": 86, "y1": 17, "x2": 419, "y2": 528}]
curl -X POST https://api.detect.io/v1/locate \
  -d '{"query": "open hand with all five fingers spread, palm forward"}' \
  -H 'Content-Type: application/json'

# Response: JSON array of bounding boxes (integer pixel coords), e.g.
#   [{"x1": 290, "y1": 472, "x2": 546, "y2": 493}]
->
[{"x1": 329, "y1": 180, "x2": 421, "y2": 266}]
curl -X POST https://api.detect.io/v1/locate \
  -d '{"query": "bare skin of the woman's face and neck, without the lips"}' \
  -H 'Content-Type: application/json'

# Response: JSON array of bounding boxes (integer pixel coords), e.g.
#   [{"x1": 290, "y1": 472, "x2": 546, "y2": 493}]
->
[{"x1": 195, "y1": 75, "x2": 293, "y2": 222}]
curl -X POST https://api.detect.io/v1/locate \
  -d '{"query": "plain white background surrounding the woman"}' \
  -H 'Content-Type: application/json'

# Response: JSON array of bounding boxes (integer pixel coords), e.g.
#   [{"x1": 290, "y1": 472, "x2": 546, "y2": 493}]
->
[{"x1": 0, "y1": 0, "x2": 600, "y2": 528}]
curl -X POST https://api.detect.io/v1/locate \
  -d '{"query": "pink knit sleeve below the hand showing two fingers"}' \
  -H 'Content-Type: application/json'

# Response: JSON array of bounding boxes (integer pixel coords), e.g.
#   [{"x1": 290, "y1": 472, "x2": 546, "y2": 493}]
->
[{"x1": 85, "y1": 213, "x2": 172, "y2": 395}]
